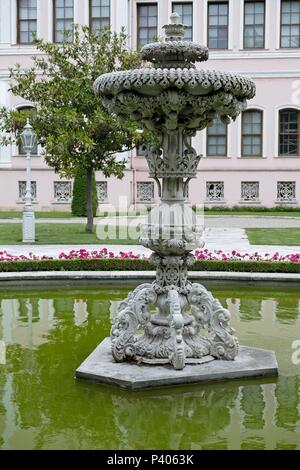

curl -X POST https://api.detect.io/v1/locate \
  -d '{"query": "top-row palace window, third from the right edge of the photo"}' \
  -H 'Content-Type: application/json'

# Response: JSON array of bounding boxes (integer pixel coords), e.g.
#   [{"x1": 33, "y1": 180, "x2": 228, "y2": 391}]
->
[{"x1": 207, "y1": 2, "x2": 229, "y2": 49}]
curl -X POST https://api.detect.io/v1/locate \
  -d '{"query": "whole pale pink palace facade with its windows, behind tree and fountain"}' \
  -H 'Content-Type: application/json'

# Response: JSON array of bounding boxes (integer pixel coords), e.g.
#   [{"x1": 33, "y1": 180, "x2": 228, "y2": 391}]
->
[{"x1": 0, "y1": 0, "x2": 300, "y2": 211}]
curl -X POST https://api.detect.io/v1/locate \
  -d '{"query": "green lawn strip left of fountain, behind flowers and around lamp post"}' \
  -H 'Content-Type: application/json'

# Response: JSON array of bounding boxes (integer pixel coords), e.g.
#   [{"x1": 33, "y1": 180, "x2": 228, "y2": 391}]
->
[{"x1": 0, "y1": 223, "x2": 138, "y2": 246}]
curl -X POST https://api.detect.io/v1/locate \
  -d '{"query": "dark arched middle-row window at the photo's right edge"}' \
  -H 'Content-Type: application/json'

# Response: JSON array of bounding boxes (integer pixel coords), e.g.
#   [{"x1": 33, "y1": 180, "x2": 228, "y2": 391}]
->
[{"x1": 279, "y1": 109, "x2": 299, "y2": 156}]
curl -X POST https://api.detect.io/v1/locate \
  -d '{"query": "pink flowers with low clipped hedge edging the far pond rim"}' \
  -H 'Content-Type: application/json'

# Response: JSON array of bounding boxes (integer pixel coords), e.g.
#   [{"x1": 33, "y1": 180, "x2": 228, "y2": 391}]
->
[{"x1": 0, "y1": 248, "x2": 300, "y2": 274}]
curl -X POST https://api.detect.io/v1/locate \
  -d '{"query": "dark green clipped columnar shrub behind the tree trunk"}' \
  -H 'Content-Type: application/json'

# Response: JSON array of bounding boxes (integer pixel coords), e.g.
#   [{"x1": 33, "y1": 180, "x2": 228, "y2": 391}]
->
[{"x1": 72, "y1": 168, "x2": 98, "y2": 217}]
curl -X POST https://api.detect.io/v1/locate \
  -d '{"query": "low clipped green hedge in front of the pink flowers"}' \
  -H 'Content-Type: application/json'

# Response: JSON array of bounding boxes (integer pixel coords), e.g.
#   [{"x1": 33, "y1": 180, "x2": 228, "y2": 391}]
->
[{"x1": 0, "y1": 258, "x2": 300, "y2": 274}]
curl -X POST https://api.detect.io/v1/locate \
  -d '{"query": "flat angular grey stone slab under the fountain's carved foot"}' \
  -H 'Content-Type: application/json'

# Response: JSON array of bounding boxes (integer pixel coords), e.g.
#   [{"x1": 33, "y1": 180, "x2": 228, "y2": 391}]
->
[{"x1": 76, "y1": 338, "x2": 278, "y2": 390}]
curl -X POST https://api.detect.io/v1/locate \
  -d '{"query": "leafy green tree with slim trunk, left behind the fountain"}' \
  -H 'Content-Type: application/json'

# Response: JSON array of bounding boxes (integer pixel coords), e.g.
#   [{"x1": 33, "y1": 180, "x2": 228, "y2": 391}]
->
[{"x1": 0, "y1": 25, "x2": 140, "y2": 232}]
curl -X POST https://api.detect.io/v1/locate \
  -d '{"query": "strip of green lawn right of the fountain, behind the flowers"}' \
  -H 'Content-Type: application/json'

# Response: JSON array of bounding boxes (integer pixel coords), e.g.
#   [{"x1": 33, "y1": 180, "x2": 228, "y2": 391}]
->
[{"x1": 246, "y1": 228, "x2": 300, "y2": 246}]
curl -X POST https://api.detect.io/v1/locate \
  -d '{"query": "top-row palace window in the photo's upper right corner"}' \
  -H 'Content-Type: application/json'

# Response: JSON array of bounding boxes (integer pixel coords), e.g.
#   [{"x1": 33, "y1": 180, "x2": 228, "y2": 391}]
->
[{"x1": 280, "y1": 0, "x2": 300, "y2": 47}]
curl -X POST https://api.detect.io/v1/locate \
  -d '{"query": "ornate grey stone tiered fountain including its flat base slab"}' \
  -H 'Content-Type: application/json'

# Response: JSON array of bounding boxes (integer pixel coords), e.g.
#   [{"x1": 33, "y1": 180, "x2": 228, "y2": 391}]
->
[{"x1": 76, "y1": 13, "x2": 277, "y2": 388}]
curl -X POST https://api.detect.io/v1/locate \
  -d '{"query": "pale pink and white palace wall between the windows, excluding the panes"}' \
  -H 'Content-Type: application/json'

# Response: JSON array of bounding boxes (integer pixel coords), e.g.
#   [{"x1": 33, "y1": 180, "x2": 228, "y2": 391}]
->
[{"x1": 0, "y1": 0, "x2": 300, "y2": 210}]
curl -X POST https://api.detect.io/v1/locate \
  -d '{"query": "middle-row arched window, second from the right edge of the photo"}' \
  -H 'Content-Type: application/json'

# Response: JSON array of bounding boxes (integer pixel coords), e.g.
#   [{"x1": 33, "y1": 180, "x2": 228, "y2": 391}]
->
[{"x1": 242, "y1": 110, "x2": 263, "y2": 157}]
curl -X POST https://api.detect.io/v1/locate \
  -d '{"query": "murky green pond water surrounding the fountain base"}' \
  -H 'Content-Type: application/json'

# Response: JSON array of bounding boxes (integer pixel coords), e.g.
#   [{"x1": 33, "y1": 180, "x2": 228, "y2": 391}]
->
[{"x1": 0, "y1": 285, "x2": 300, "y2": 450}]
